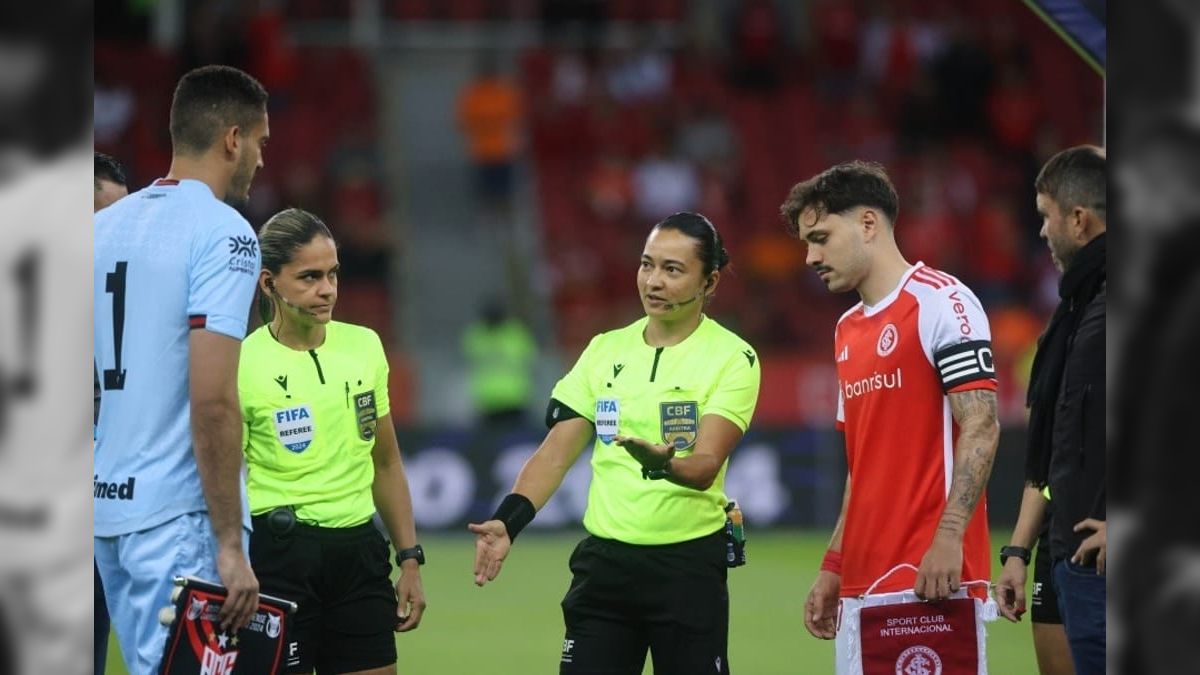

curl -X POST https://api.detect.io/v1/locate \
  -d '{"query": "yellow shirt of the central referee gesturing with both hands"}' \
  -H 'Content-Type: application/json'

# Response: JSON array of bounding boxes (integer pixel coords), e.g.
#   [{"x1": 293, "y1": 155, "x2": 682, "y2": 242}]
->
[{"x1": 551, "y1": 317, "x2": 761, "y2": 544}]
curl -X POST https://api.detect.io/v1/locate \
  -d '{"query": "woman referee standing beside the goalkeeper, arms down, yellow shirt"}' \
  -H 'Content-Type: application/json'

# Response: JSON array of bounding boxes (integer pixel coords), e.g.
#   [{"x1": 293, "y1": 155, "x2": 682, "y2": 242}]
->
[{"x1": 238, "y1": 209, "x2": 425, "y2": 675}]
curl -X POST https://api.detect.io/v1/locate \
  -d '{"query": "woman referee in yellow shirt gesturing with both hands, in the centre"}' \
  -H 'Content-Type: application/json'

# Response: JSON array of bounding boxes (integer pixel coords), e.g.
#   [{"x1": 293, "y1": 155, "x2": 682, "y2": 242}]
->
[{"x1": 469, "y1": 213, "x2": 760, "y2": 675}]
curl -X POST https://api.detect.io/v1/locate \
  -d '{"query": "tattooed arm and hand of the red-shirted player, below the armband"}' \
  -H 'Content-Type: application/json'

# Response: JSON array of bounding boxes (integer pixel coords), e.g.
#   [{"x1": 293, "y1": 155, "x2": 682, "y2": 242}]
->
[{"x1": 913, "y1": 389, "x2": 1000, "y2": 601}]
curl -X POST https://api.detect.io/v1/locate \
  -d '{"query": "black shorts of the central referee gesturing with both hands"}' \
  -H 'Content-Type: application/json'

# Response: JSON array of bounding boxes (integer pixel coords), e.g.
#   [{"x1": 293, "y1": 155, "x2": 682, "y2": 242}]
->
[{"x1": 559, "y1": 530, "x2": 730, "y2": 675}]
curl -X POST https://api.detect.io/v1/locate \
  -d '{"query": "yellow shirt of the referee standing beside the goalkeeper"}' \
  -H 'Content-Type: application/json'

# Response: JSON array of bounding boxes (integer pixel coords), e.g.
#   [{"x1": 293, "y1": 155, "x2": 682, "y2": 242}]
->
[{"x1": 238, "y1": 321, "x2": 390, "y2": 527}]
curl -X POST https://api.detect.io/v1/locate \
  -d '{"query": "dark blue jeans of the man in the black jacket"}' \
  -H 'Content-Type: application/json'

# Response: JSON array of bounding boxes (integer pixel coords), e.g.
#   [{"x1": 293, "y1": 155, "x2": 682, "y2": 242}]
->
[{"x1": 1052, "y1": 558, "x2": 1108, "y2": 675}]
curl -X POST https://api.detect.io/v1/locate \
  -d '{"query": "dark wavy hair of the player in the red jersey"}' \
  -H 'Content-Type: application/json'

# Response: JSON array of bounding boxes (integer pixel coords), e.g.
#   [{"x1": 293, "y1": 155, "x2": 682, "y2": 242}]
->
[{"x1": 779, "y1": 160, "x2": 900, "y2": 237}]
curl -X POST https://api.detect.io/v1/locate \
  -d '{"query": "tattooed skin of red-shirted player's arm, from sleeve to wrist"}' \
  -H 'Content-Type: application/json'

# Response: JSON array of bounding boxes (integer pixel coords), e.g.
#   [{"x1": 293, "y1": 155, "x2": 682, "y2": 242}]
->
[{"x1": 937, "y1": 389, "x2": 1000, "y2": 534}]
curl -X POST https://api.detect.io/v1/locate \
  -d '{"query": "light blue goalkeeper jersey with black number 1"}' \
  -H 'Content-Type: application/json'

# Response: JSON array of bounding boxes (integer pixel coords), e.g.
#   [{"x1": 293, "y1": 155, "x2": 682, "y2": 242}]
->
[{"x1": 92, "y1": 180, "x2": 262, "y2": 537}]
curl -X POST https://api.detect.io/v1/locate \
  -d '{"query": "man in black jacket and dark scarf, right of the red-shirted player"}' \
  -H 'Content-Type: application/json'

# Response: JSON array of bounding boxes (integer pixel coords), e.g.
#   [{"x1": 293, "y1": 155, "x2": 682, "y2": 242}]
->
[{"x1": 997, "y1": 145, "x2": 1108, "y2": 675}]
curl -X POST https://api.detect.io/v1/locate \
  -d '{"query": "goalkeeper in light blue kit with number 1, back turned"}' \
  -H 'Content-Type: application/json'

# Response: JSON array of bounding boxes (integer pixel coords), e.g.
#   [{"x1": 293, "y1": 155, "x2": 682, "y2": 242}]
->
[{"x1": 92, "y1": 66, "x2": 269, "y2": 675}]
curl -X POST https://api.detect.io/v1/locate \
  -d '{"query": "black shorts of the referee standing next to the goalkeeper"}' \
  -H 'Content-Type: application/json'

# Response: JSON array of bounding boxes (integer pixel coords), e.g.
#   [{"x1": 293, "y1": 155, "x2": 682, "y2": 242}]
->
[{"x1": 250, "y1": 516, "x2": 397, "y2": 674}]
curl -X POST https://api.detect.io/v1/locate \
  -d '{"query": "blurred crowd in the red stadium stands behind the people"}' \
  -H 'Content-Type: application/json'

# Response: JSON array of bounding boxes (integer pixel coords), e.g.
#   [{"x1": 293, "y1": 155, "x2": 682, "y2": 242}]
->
[{"x1": 95, "y1": 0, "x2": 1104, "y2": 423}]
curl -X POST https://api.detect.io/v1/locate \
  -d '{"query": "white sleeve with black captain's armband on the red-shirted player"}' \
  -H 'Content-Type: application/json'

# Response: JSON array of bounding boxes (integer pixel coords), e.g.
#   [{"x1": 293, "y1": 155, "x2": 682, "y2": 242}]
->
[{"x1": 920, "y1": 283, "x2": 996, "y2": 394}]
